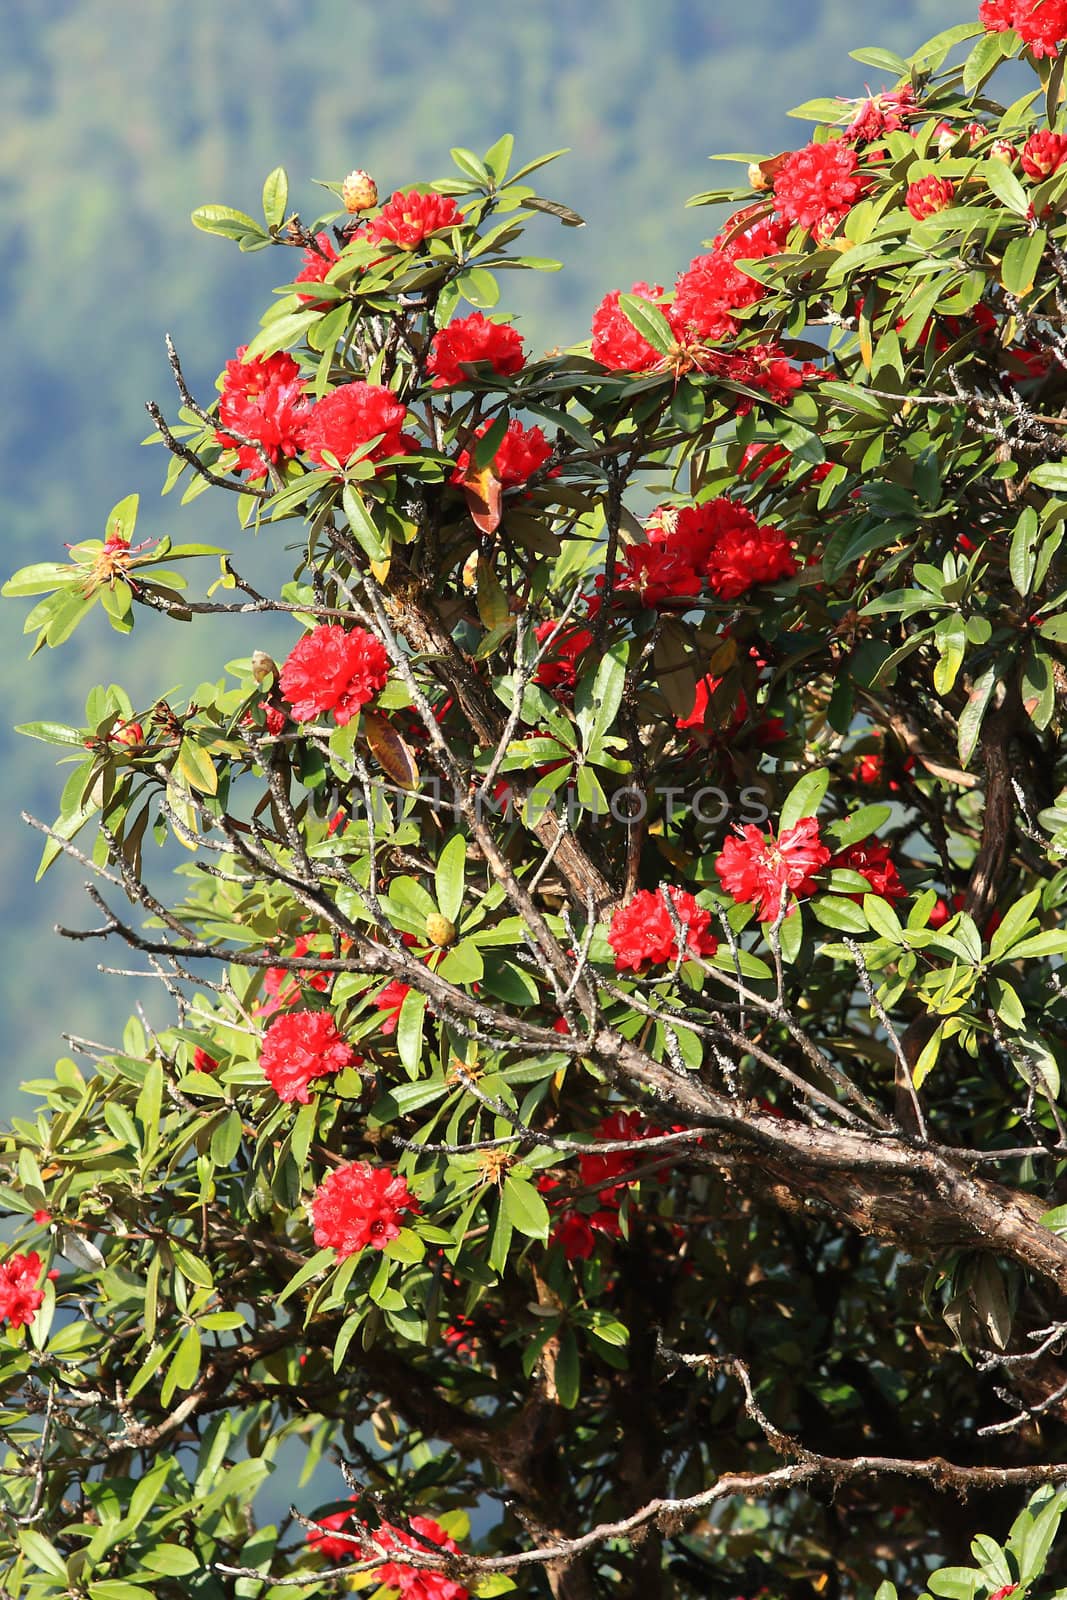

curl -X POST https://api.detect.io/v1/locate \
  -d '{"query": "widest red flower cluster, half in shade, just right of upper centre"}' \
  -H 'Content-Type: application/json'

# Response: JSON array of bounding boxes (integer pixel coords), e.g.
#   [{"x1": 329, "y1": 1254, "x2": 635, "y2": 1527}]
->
[{"x1": 616, "y1": 494, "x2": 797, "y2": 606}]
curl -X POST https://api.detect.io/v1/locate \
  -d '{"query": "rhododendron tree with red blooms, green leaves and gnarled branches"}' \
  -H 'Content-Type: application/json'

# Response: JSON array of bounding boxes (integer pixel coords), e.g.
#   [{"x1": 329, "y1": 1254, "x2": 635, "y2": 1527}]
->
[{"x1": 12, "y1": 15, "x2": 1067, "y2": 1600}]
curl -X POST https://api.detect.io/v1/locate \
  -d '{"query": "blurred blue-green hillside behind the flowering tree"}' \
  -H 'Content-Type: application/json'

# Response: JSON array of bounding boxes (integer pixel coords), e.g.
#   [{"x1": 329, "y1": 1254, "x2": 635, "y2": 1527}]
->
[{"x1": 0, "y1": 0, "x2": 976, "y2": 1115}]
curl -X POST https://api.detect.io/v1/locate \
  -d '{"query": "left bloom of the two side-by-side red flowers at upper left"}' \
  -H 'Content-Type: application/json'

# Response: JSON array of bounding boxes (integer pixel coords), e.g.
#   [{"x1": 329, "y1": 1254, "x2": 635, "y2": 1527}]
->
[{"x1": 214, "y1": 344, "x2": 312, "y2": 480}]
